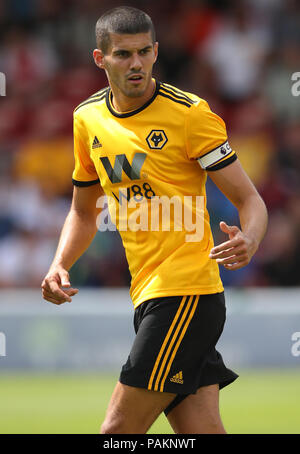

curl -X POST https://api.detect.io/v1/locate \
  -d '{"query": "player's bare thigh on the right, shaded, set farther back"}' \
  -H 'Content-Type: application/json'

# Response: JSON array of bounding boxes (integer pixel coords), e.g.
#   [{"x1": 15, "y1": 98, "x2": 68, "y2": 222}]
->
[{"x1": 168, "y1": 384, "x2": 226, "y2": 434}]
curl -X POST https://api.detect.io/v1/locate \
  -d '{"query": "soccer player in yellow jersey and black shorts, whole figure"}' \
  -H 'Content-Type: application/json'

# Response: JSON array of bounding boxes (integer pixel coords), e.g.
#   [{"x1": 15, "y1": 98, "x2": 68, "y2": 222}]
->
[{"x1": 42, "y1": 7, "x2": 267, "y2": 434}]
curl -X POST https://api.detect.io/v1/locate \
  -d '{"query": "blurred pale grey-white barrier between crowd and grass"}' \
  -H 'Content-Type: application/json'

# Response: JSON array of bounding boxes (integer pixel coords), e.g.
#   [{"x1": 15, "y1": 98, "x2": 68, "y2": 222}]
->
[{"x1": 0, "y1": 288, "x2": 300, "y2": 371}]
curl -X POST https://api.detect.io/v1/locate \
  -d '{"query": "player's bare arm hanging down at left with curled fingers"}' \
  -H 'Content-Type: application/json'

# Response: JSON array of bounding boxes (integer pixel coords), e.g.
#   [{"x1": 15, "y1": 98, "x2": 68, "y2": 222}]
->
[{"x1": 41, "y1": 184, "x2": 103, "y2": 305}]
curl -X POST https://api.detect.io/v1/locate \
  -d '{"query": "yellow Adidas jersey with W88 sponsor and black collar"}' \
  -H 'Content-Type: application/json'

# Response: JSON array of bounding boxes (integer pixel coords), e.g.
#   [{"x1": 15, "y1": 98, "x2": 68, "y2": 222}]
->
[{"x1": 72, "y1": 81, "x2": 237, "y2": 308}]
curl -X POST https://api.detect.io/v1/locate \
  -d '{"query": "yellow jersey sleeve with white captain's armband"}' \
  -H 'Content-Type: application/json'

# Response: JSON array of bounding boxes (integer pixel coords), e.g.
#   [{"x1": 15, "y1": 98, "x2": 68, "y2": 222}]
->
[{"x1": 186, "y1": 99, "x2": 237, "y2": 171}]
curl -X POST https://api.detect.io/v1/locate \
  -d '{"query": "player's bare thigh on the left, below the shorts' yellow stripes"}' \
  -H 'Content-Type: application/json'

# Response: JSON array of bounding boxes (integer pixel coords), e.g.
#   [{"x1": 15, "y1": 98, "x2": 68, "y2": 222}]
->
[{"x1": 101, "y1": 382, "x2": 175, "y2": 434}]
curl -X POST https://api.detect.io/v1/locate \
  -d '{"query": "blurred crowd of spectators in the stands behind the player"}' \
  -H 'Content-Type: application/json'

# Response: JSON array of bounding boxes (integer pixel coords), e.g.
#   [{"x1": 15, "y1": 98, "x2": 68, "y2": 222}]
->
[{"x1": 0, "y1": 0, "x2": 300, "y2": 288}]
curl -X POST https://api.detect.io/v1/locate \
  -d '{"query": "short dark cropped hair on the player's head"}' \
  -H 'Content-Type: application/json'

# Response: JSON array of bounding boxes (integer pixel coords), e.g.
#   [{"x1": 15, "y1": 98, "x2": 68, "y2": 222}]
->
[{"x1": 96, "y1": 6, "x2": 155, "y2": 54}]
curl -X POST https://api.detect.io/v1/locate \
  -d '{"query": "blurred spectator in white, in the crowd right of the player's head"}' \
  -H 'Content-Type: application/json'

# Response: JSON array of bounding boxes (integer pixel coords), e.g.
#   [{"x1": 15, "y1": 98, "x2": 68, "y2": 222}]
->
[{"x1": 199, "y1": 1, "x2": 270, "y2": 102}]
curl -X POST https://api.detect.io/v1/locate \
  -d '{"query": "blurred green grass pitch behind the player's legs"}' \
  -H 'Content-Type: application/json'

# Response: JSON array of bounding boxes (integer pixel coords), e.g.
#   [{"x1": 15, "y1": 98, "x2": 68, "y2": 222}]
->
[{"x1": 0, "y1": 369, "x2": 300, "y2": 434}]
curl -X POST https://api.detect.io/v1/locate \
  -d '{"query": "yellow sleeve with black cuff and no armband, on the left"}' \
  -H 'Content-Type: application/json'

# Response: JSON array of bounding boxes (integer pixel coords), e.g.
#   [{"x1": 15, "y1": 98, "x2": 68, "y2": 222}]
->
[{"x1": 72, "y1": 114, "x2": 100, "y2": 186}]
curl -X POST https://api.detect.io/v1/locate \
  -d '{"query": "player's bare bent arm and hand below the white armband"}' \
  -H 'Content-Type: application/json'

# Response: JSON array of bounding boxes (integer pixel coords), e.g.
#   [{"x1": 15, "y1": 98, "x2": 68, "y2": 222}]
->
[{"x1": 208, "y1": 160, "x2": 268, "y2": 270}]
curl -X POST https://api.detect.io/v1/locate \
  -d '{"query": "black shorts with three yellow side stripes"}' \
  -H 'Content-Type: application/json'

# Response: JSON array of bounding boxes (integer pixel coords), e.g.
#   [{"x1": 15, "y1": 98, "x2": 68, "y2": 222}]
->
[{"x1": 119, "y1": 292, "x2": 238, "y2": 414}]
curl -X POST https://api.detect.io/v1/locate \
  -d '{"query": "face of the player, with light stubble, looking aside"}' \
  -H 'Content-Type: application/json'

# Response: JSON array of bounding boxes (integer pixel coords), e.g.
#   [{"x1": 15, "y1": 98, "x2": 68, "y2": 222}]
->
[{"x1": 94, "y1": 32, "x2": 158, "y2": 98}]
